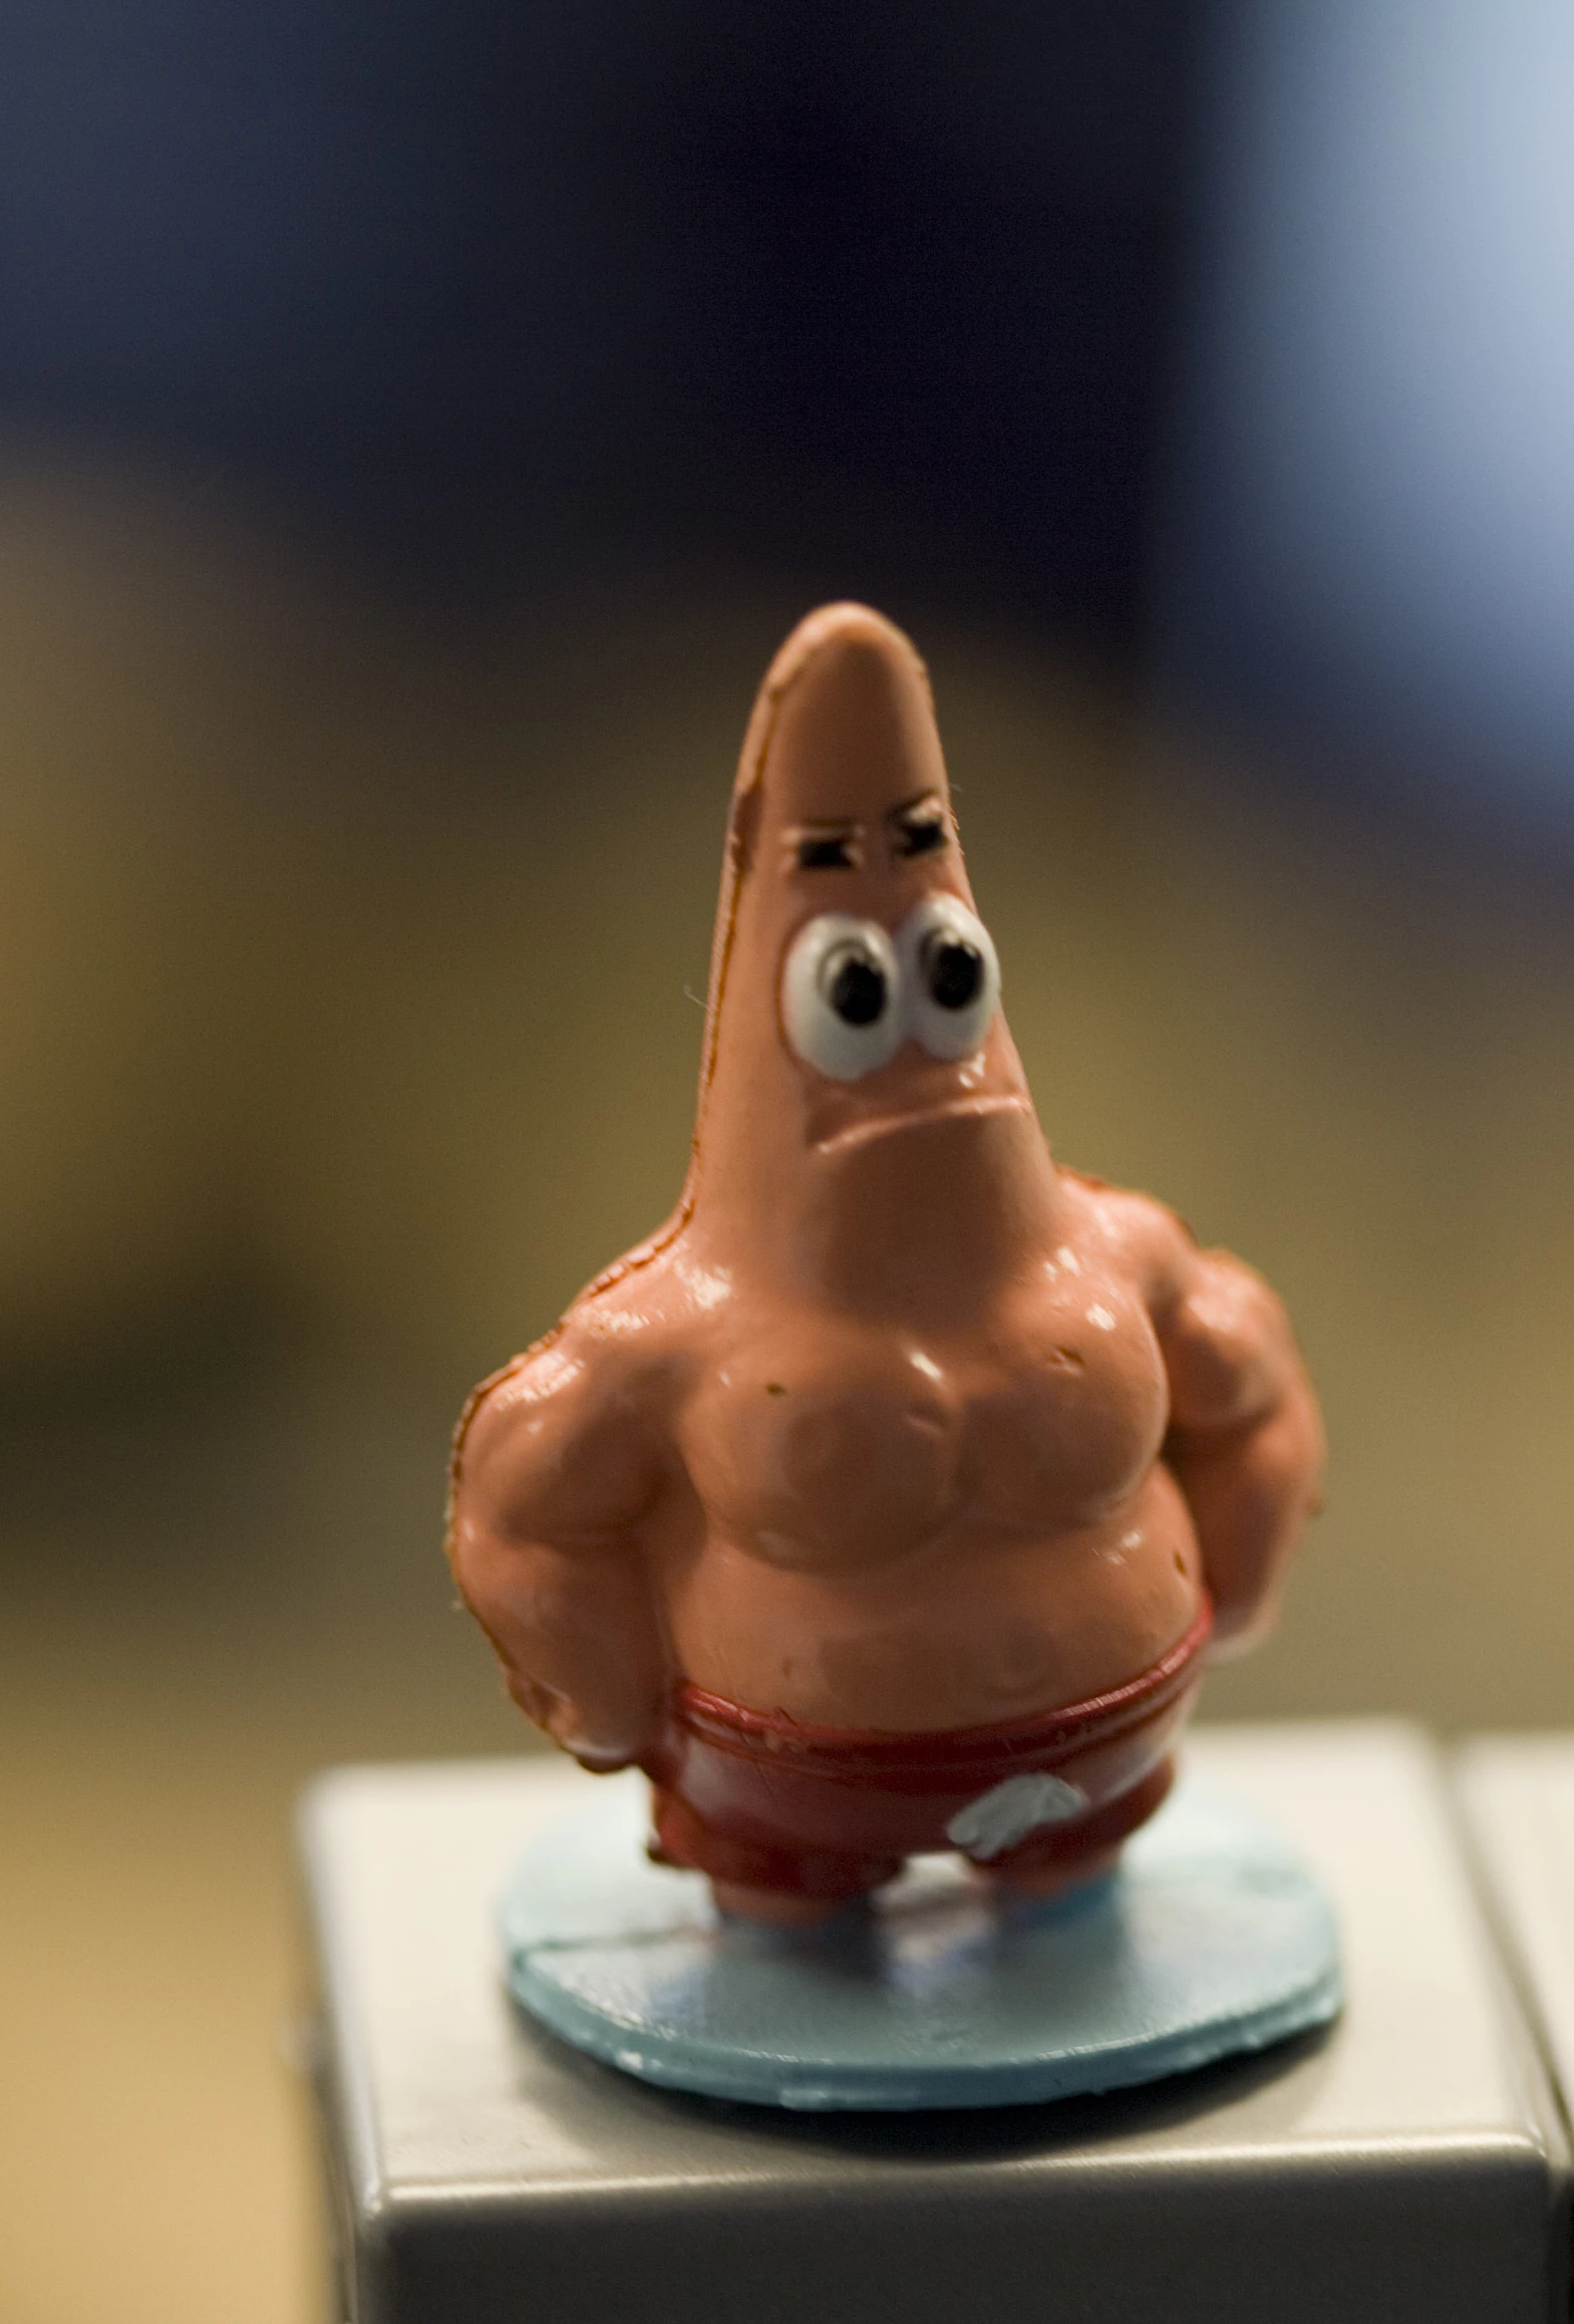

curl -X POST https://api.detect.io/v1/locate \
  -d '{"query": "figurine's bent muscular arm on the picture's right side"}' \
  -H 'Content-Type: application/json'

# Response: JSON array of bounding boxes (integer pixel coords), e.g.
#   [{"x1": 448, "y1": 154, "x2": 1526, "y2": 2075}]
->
[{"x1": 1153, "y1": 1220, "x2": 1323, "y2": 1654}]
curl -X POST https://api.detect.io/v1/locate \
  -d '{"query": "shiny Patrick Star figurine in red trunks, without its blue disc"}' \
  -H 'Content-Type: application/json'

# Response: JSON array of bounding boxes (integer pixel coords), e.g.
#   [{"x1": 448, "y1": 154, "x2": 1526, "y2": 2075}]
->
[{"x1": 449, "y1": 604, "x2": 1323, "y2": 2007}]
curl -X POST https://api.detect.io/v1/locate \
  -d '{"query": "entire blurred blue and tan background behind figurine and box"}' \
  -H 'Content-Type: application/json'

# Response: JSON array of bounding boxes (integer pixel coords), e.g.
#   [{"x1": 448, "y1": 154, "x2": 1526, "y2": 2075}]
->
[{"x1": 0, "y1": 0, "x2": 1574, "y2": 2324}]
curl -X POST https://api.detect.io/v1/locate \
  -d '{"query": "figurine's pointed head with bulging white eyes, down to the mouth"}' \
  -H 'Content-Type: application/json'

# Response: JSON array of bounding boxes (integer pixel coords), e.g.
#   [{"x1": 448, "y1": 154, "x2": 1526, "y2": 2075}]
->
[{"x1": 695, "y1": 604, "x2": 1037, "y2": 1273}]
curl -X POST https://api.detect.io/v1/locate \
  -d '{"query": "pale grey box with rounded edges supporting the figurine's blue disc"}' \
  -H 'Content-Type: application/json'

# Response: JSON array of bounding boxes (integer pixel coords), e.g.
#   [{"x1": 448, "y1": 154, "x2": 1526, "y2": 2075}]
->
[{"x1": 302, "y1": 1724, "x2": 1574, "y2": 2324}]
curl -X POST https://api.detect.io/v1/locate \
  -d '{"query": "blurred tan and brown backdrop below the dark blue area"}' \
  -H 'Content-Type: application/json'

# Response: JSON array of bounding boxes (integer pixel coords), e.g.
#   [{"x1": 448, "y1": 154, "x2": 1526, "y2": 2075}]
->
[{"x1": 0, "y1": 446, "x2": 1574, "y2": 2324}]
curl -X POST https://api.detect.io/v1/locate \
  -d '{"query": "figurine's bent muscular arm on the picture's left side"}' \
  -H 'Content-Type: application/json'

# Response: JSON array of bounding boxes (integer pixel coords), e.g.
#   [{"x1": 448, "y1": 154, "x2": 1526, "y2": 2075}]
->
[{"x1": 449, "y1": 1322, "x2": 667, "y2": 1771}]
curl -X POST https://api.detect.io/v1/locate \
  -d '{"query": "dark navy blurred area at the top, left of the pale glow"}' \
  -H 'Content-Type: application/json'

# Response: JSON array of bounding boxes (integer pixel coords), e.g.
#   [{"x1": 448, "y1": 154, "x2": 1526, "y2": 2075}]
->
[{"x1": 0, "y1": 0, "x2": 1197, "y2": 644}]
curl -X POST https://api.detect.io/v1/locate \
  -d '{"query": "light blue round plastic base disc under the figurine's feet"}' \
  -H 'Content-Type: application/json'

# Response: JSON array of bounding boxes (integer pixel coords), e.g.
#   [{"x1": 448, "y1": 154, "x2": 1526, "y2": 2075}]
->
[{"x1": 502, "y1": 1776, "x2": 1342, "y2": 2110}]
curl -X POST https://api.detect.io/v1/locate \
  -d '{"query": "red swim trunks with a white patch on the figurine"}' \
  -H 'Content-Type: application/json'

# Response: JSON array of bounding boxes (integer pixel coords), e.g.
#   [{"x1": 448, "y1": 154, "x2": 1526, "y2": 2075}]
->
[{"x1": 642, "y1": 1603, "x2": 1213, "y2": 1896}]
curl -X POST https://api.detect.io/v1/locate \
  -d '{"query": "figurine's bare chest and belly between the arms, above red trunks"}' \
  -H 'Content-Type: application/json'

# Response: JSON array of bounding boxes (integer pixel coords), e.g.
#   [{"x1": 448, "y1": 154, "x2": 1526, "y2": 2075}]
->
[{"x1": 646, "y1": 1244, "x2": 1199, "y2": 1731}]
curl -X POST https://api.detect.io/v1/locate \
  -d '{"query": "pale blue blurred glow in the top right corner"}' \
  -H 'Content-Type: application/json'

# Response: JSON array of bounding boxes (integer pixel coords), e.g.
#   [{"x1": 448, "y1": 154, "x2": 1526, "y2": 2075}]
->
[{"x1": 1165, "y1": 0, "x2": 1574, "y2": 818}]
